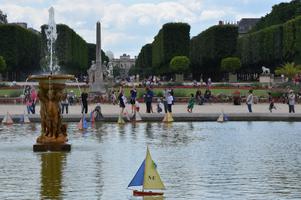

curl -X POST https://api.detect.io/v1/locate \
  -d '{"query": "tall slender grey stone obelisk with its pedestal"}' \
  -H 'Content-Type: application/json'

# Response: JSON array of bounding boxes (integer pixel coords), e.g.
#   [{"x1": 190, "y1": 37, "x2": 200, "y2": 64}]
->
[{"x1": 88, "y1": 21, "x2": 105, "y2": 93}]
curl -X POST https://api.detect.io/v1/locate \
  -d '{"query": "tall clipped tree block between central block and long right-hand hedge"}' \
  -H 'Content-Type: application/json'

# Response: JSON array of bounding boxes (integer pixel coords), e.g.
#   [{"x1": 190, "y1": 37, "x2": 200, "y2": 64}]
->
[{"x1": 190, "y1": 25, "x2": 238, "y2": 78}]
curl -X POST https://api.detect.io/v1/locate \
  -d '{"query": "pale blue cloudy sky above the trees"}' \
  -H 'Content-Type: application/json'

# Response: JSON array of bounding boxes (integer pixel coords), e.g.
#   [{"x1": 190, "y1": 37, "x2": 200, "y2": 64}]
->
[{"x1": 0, "y1": 0, "x2": 288, "y2": 58}]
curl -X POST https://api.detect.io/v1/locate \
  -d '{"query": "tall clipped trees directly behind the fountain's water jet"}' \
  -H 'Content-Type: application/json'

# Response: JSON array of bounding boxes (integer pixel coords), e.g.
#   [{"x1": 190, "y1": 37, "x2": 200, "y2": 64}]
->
[{"x1": 41, "y1": 24, "x2": 88, "y2": 74}]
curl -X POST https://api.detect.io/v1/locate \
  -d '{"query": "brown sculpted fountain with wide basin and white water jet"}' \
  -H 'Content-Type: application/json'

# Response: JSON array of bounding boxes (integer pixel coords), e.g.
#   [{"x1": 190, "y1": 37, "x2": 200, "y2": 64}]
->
[{"x1": 28, "y1": 7, "x2": 75, "y2": 151}]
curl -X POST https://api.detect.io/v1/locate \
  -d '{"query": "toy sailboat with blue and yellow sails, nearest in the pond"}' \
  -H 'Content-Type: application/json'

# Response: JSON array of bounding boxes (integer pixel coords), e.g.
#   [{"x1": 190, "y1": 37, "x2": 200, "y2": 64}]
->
[{"x1": 128, "y1": 147, "x2": 165, "y2": 196}]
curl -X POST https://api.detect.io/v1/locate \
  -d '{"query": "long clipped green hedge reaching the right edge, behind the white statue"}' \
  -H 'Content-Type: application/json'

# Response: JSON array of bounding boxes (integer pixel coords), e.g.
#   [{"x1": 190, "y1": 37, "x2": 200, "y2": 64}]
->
[{"x1": 237, "y1": 16, "x2": 301, "y2": 72}]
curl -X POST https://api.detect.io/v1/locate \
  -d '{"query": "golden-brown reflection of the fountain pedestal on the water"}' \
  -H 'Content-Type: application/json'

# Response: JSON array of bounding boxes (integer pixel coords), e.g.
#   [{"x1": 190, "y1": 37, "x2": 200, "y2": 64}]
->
[{"x1": 40, "y1": 152, "x2": 66, "y2": 199}]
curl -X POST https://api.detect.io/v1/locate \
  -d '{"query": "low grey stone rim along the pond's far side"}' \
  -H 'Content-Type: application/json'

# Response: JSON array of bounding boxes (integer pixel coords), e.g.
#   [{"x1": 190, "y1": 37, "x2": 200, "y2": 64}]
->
[{"x1": 0, "y1": 113, "x2": 301, "y2": 123}]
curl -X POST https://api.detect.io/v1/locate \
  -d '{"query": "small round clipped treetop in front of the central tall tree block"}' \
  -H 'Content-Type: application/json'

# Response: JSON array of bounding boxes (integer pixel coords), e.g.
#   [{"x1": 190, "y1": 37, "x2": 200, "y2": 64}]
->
[{"x1": 169, "y1": 56, "x2": 190, "y2": 74}]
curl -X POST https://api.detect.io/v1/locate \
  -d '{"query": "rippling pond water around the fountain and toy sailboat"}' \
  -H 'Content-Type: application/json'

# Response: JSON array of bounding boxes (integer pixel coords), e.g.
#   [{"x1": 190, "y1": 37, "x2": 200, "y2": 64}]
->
[{"x1": 0, "y1": 122, "x2": 301, "y2": 200}]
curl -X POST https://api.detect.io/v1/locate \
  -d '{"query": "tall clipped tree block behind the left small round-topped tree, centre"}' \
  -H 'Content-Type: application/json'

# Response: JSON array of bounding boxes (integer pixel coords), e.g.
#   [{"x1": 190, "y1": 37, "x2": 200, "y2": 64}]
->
[{"x1": 152, "y1": 23, "x2": 190, "y2": 74}]
